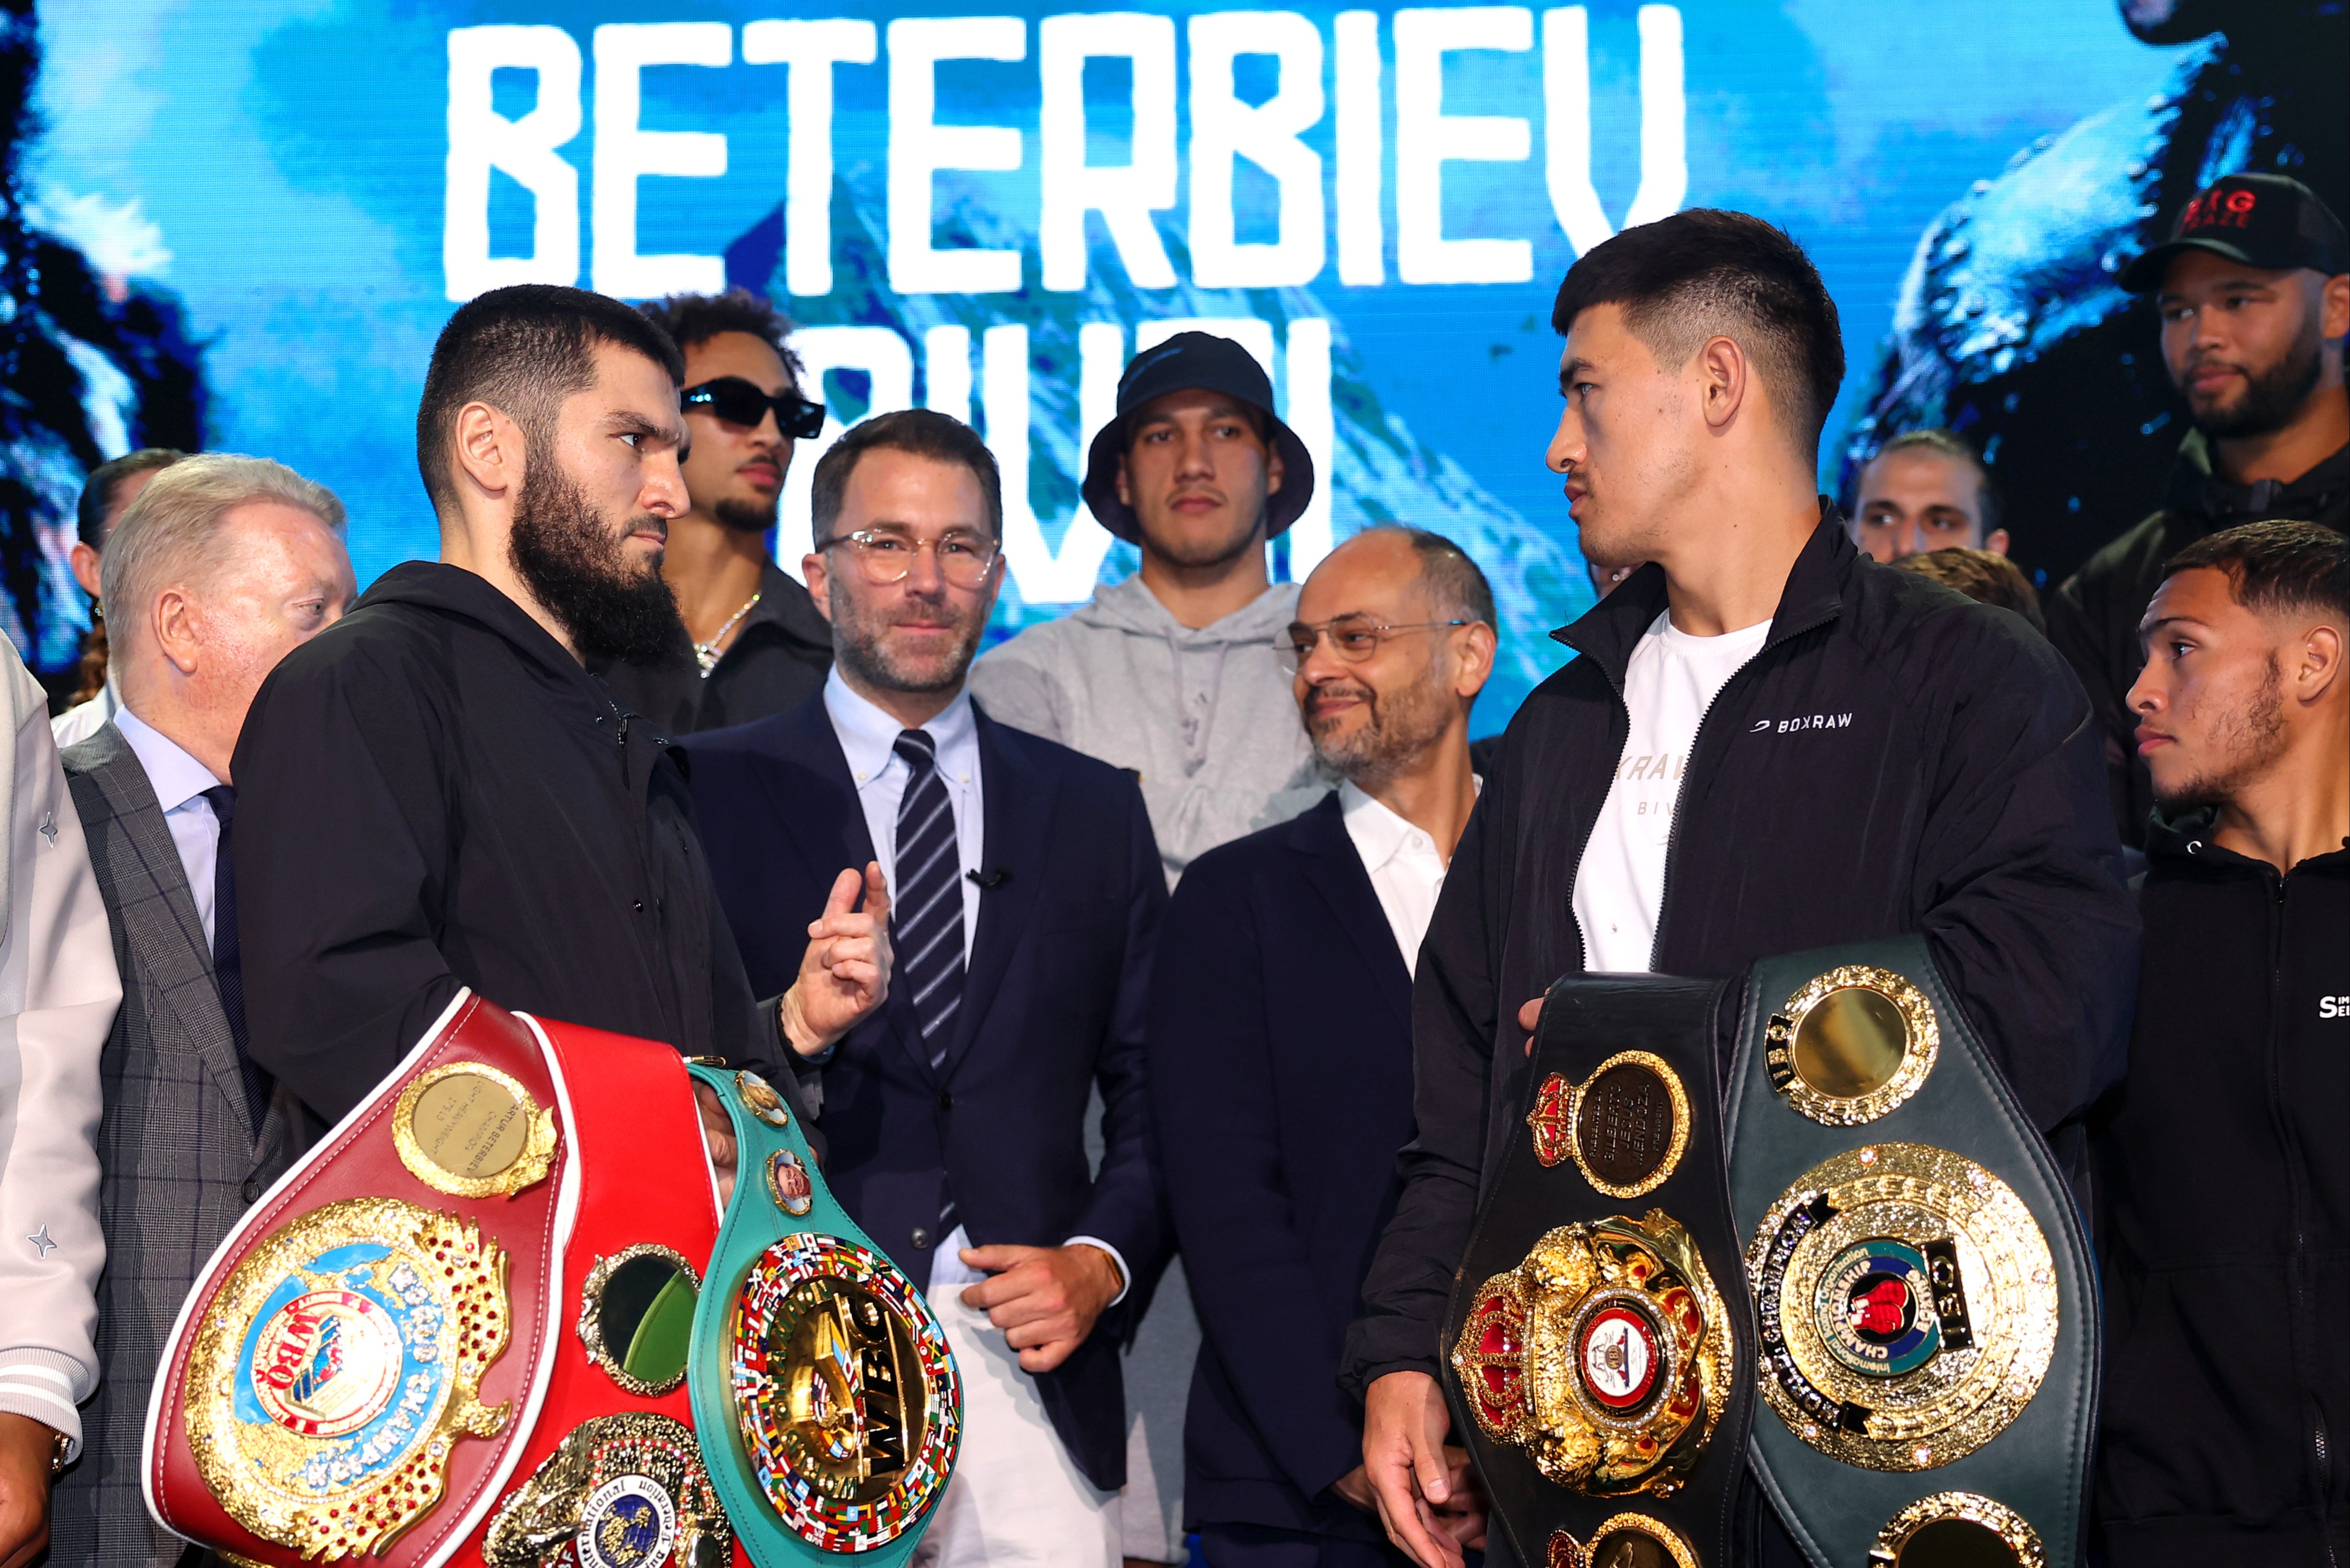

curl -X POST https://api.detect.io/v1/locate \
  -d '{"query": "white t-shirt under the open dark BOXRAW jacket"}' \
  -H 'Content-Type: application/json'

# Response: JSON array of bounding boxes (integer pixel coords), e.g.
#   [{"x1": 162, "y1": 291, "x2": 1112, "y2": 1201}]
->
[{"x1": 1575, "y1": 611, "x2": 1770, "y2": 973}]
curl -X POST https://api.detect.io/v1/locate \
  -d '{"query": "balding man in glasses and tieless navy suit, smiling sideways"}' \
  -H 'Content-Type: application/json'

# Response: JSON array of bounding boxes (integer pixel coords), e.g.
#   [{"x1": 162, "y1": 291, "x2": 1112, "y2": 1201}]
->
[{"x1": 1149, "y1": 529, "x2": 1495, "y2": 1568}]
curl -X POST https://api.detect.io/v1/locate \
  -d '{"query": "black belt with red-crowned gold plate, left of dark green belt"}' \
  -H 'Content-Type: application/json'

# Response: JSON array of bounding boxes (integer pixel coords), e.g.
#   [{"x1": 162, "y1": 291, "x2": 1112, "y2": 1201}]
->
[{"x1": 1443, "y1": 976, "x2": 1755, "y2": 1568}]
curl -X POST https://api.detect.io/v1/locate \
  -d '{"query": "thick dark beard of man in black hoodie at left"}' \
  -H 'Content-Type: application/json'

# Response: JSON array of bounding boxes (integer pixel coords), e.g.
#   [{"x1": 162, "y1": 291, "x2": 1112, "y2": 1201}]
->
[{"x1": 508, "y1": 451, "x2": 691, "y2": 663}]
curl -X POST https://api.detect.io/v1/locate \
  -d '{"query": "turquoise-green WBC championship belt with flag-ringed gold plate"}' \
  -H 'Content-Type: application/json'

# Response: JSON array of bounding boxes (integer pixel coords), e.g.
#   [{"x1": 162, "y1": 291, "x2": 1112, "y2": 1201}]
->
[{"x1": 689, "y1": 1065, "x2": 963, "y2": 1568}]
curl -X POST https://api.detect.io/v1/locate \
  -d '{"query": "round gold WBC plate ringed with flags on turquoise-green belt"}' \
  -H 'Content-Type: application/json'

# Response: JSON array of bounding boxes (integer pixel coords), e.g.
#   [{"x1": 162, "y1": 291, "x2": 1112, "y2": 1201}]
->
[{"x1": 728, "y1": 1232, "x2": 961, "y2": 1551}]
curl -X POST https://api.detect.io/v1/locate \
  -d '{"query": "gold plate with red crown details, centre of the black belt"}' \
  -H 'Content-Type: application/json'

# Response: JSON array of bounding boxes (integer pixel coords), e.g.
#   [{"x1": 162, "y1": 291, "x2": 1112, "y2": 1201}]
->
[{"x1": 1452, "y1": 1208, "x2": 1732, "y2": 1497}]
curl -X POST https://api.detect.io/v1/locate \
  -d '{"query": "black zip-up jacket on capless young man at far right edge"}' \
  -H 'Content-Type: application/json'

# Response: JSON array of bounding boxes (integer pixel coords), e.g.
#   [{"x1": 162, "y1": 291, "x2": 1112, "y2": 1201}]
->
[{"x1": 2091, "y1": 811, "x2": 2350, "y2": 1568}]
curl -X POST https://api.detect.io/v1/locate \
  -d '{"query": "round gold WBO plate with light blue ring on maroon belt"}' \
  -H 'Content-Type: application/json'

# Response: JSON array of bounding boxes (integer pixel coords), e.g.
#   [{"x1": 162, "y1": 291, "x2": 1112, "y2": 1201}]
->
[{"x1": 188, "y1": 1199, "x2": 510, "y2": 1561}]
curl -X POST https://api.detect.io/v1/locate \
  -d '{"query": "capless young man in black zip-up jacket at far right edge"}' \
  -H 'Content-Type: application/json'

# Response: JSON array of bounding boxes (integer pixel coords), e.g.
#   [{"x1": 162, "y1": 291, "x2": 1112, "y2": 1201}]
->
[{"x1": 2094, "y1": 522, "x2": 2350, "y2": 1568}]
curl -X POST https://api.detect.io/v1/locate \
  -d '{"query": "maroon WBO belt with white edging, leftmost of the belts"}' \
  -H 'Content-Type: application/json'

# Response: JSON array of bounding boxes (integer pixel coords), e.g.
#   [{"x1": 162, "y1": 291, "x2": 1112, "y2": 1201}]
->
[{"x1": 143, "y1": 992, "x2": 580, "y2": 1568}]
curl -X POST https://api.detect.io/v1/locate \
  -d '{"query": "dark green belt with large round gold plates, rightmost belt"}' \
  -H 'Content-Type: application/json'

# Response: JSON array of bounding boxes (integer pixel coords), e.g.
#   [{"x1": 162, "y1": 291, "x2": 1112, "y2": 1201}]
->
[{"x1": 1725, "y1": 938, "x2": 2098, "y2": 1568}]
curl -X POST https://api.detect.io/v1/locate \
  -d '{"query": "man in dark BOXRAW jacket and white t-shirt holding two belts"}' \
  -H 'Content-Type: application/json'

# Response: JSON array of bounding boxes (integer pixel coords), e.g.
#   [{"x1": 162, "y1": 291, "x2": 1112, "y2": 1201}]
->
[{"x1": 1342, "y1": 212, "x2": 2136, "y2": 1568}]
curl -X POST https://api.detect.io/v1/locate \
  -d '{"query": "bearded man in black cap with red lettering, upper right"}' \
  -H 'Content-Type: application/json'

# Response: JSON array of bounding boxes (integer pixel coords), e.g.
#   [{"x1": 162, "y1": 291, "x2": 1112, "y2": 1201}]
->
[{"x1": 2047, "y1": 174, "x2": 2350, "y2": 846}]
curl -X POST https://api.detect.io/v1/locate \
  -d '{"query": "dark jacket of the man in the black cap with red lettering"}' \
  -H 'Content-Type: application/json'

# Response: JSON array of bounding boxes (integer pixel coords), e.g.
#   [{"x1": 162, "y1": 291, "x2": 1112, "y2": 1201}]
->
[{"x1": 2047, "y1": 430, "x2": 2350, "y2": 849}]
